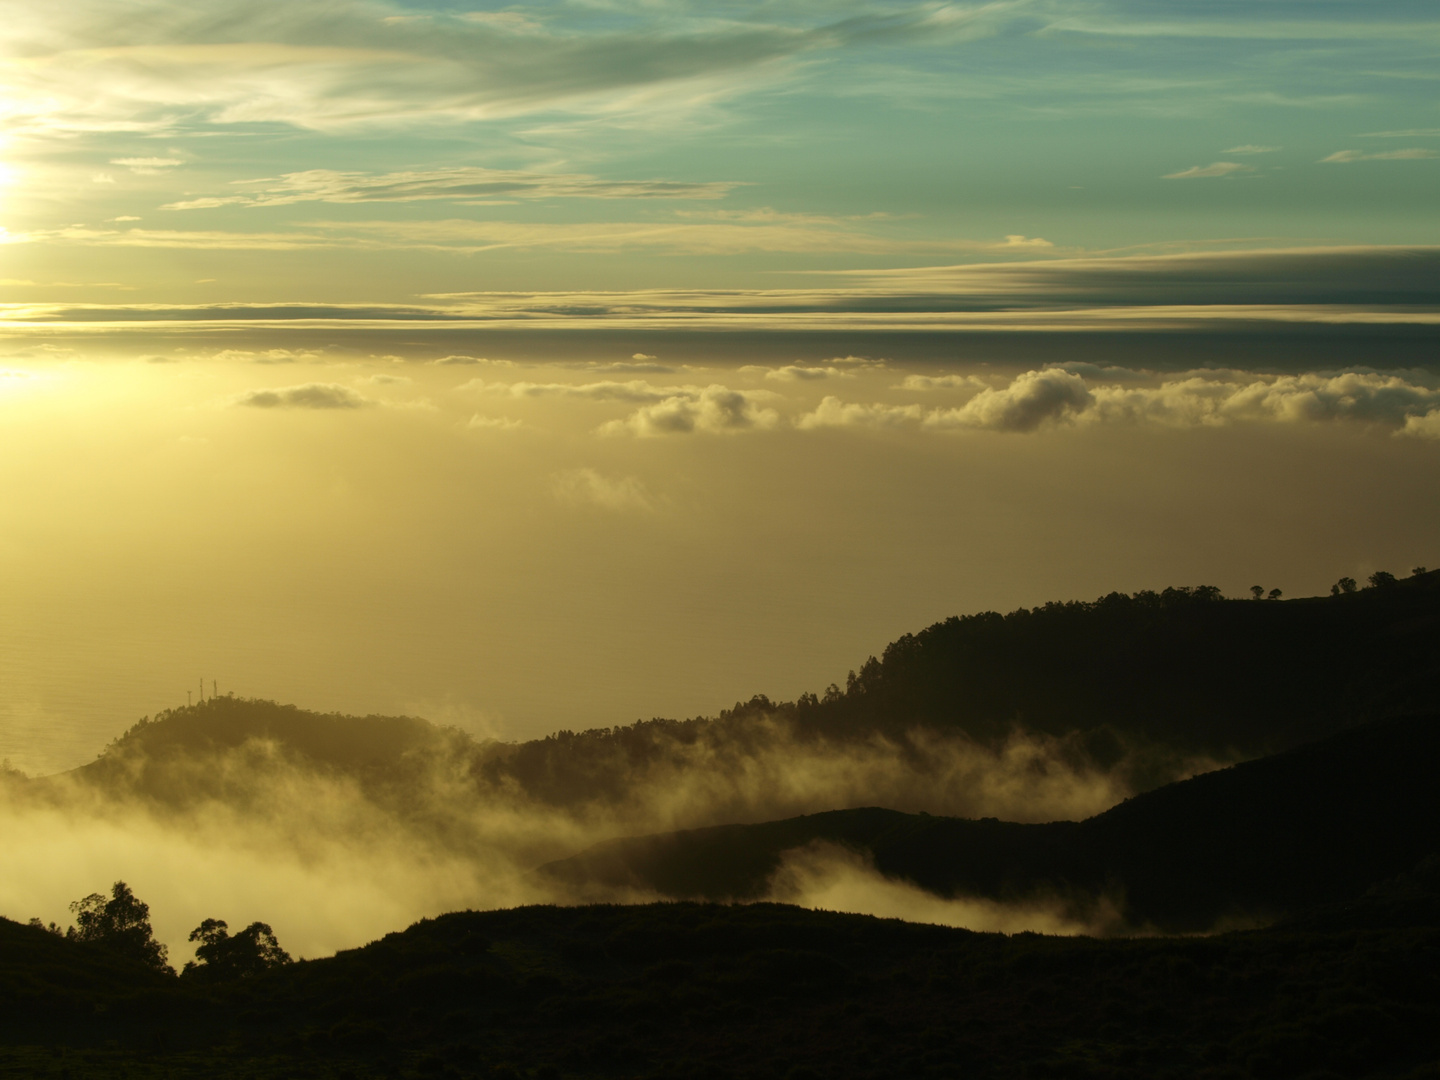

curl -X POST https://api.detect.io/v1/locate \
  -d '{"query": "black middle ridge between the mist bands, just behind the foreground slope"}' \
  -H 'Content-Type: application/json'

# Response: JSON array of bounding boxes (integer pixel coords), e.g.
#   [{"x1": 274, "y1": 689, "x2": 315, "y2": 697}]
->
[{"x1": 540, "y1": 716, "x2": 1440, "y2": 932}]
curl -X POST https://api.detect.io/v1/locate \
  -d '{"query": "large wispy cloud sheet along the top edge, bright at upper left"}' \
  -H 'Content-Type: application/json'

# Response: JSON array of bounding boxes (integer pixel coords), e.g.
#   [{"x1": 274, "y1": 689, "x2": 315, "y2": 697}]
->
[{"x1": 0, "y1": 0, "x2": 1031, "y2": 135}]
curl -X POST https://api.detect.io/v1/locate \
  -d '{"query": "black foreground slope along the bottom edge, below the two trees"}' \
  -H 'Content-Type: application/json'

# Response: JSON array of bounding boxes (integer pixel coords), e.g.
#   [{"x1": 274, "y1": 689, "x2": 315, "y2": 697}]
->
[{"x1": 0, "y1": 881, "x2": 1440, "y2": 1080}]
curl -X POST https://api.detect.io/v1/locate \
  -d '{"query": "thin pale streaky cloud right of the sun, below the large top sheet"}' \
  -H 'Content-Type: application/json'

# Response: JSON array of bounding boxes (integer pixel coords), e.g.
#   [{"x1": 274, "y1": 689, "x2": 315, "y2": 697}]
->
[{"x1": 163, "y1": 168, "x2": 736, "y2": 210}]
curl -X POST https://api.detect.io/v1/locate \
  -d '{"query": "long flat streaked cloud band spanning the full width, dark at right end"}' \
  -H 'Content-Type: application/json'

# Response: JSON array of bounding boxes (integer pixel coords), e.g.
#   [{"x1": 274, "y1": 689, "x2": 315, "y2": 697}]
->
[{"x1": 11, "y1": 249, "x2": 1440, "y2": 334}]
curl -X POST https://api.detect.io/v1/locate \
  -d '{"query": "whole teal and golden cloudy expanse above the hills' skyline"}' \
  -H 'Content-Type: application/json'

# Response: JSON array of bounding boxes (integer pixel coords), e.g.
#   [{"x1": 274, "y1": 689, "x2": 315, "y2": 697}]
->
[{"x1": 0, "y1": 0, "x2": 1440, "y2": 772}]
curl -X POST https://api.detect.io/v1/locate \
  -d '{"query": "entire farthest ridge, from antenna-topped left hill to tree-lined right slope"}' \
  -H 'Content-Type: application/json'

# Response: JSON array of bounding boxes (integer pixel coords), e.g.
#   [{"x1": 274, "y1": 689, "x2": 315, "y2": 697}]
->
[{"x1": 45, "y1": 572, "x2": 1440, "y2": 824}]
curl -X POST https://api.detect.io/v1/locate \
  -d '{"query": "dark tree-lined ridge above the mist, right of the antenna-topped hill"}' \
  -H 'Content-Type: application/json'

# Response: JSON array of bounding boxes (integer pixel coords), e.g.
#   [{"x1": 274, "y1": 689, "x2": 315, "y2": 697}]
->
[{"x1": 481, "y1": 570, "x2": 1440, "y2": 802}]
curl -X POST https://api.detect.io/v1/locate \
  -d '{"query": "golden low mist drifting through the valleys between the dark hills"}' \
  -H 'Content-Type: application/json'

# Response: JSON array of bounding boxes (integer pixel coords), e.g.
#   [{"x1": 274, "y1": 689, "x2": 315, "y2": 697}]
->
[{"x1": 0, "y1": 698, "x2": 1215, "y2": 965}]
